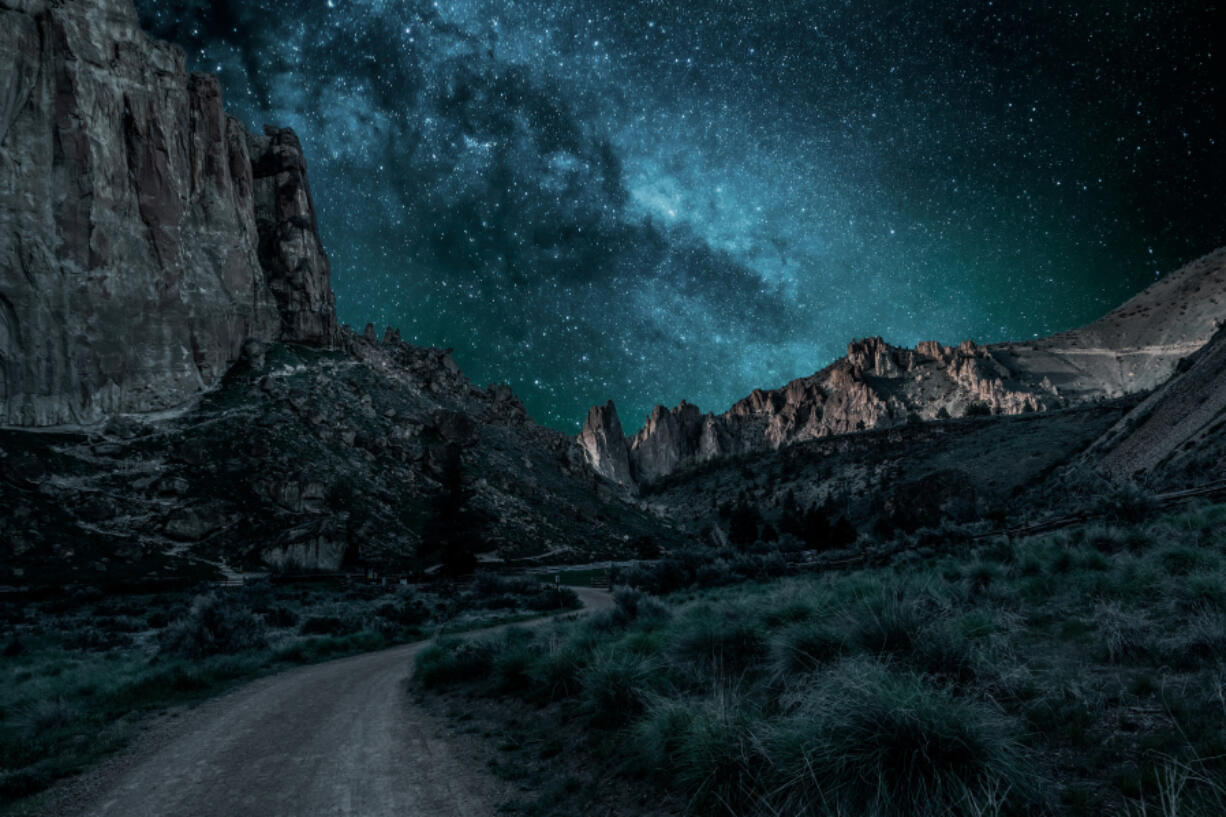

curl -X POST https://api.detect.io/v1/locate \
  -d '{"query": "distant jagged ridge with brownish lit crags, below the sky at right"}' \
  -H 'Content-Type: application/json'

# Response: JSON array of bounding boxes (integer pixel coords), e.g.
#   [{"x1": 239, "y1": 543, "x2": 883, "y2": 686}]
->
[{"x1": 576, "y1": 249, "x2": 1226, "y2": 488}]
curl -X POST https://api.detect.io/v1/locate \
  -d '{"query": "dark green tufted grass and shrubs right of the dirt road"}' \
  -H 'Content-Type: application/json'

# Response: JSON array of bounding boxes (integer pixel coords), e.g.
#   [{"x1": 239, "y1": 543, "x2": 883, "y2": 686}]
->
[{"x1": 417, "y1": 502, "x2": 1226, "y2": 817}]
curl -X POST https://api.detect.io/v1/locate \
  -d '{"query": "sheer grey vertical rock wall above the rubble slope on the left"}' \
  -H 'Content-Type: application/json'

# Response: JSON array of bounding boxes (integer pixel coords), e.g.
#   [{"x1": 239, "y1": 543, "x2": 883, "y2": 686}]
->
[{"x1": 0, "y1": 0, "x2": 335, "y2": 426}]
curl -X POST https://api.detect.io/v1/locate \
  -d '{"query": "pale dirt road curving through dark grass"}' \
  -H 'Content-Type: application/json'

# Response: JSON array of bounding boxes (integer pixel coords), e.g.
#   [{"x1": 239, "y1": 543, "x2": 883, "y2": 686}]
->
[{"x1": 51, "y1": 588, "x2": 612, "y2": 817}]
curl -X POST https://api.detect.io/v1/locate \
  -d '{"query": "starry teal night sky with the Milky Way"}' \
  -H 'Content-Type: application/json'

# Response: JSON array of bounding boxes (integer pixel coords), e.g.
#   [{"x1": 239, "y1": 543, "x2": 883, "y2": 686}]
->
[{"x1": 137, "y1": 0, "x2": 1226, "y2": 432}]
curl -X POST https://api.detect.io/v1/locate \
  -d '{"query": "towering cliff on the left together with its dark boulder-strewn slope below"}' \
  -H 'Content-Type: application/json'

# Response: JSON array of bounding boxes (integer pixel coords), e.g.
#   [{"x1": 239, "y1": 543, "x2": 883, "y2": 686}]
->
[{"x1": 0, "y1": 0, "x2": 667, "y2": 585}]
